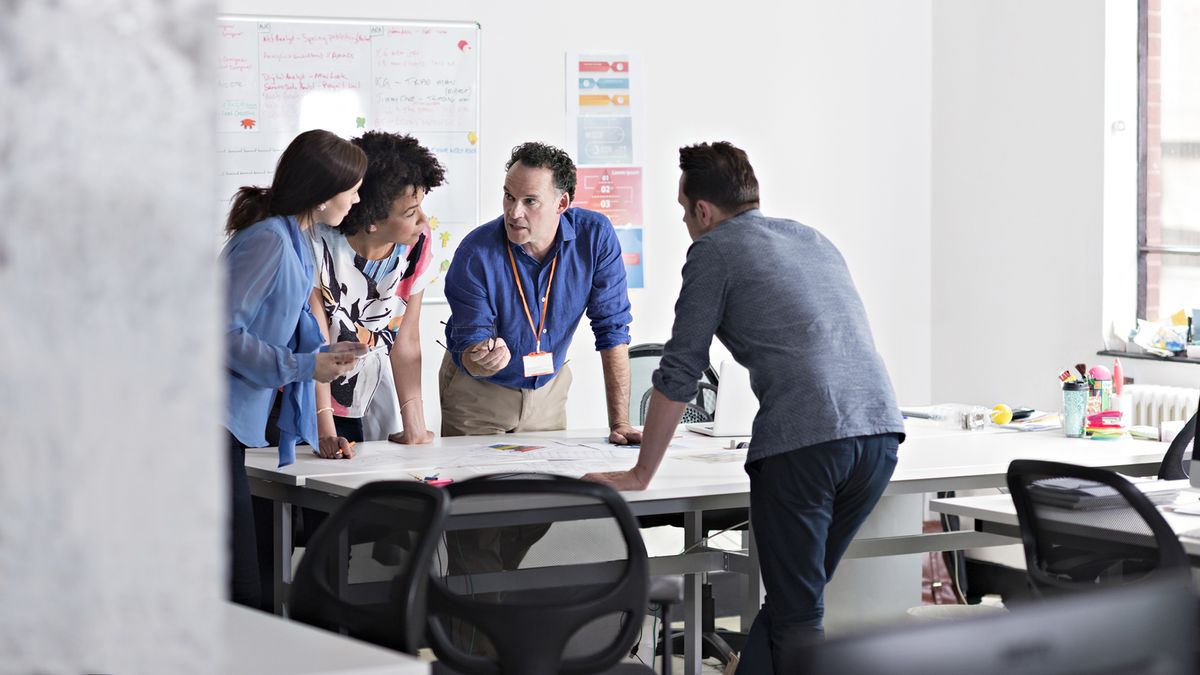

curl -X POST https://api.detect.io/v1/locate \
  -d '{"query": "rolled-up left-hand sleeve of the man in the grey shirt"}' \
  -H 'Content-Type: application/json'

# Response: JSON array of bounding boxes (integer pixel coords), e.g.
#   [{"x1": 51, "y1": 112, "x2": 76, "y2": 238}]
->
[{"x1": 652, "y1": 240, "x2": 726, "y2": 402}]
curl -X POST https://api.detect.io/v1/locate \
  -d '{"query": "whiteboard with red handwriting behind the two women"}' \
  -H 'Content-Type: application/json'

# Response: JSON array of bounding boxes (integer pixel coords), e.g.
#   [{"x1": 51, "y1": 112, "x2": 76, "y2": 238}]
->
[{"x1": 216, "y1": 16, "x2": 480, "y2": 301}]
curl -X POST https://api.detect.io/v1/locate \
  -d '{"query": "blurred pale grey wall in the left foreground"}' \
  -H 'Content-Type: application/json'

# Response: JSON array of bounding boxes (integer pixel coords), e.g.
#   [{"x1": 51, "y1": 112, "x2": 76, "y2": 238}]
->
[{"x1": 0, "y1": 0, "x2": 228, "y2": 674}]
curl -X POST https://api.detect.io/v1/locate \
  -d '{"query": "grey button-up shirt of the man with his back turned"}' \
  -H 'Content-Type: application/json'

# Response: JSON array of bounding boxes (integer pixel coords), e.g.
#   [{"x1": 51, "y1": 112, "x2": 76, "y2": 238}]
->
[{"x1": 653, "y1": 209, "x2": 904, "y2": 461}]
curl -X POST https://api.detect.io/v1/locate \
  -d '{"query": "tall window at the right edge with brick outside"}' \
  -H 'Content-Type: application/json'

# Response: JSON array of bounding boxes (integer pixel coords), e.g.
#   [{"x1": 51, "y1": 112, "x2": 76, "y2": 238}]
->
[{"x1": 1138, "y1": 0, "x2": 1200, "y2": 319}]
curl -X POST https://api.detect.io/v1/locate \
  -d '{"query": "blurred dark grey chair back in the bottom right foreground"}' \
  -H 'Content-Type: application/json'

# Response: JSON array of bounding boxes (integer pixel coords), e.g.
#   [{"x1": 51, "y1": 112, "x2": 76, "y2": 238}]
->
[{"x1": 792, "y1": 571, "x2": 1196, "y2": 675}]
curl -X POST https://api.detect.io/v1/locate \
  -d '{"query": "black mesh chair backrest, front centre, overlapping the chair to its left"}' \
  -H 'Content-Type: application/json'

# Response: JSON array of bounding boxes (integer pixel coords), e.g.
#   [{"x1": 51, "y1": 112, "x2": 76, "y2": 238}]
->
[{"x1": 428, "y1": 474, "x2": 649, "y2": 675}]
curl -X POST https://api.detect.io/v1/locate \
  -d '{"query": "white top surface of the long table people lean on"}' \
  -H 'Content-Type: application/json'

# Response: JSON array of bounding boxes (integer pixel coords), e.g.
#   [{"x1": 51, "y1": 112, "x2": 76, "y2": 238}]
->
[{"x1": 246, "y1": 419, "x2": 1166, "y2": 502}]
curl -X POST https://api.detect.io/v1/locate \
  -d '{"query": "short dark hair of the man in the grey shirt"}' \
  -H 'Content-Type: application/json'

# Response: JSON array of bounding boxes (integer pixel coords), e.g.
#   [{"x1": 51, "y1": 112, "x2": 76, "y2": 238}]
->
[{"x1": 679, "y1": 141, "x2": 758, "y2": 211}]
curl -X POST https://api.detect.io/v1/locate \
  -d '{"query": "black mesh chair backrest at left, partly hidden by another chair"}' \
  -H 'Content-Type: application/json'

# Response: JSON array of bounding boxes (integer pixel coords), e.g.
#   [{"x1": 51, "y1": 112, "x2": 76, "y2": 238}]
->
[{"x1": 288, "y1": 480, "x2": 450, "y2": 655}]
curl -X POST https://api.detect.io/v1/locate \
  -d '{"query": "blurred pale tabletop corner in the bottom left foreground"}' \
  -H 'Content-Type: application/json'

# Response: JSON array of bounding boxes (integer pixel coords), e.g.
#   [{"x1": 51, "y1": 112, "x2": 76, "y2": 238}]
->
[{"x1": 222, "y1": 603, "x2": 430, "y2": 675}]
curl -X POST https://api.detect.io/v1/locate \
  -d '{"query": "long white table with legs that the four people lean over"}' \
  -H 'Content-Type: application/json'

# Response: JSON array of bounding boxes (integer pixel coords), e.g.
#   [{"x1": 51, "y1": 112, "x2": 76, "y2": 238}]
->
[{"x1": 246, "y1": 419, "x2": 1166, "y2": 675}]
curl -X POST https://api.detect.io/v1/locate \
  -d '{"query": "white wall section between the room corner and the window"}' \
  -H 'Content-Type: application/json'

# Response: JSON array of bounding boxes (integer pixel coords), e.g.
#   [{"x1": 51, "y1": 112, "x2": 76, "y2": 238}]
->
[{"x1": 931, "y1": 0, "x2": 1108, "y2": 410}]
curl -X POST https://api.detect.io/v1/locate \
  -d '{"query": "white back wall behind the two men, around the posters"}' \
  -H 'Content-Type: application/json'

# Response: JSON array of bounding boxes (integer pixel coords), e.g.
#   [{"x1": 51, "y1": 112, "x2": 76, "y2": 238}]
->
[{"x1": 222, "y1": 0, "x2": 930, "y2": 429}]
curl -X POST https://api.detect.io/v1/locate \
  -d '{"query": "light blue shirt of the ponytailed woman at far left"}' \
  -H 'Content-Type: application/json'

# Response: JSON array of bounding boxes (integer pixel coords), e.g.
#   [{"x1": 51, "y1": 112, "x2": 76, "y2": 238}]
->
[{"x1": 221, "y1": 216, "x2": 322, "y2": 461}]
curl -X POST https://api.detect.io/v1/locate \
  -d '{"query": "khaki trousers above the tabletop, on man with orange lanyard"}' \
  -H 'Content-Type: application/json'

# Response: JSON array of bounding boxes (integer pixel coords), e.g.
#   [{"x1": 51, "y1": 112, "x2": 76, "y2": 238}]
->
[{"x1": 438, "y1": 345, "x2": 571, "y2": 436}]
